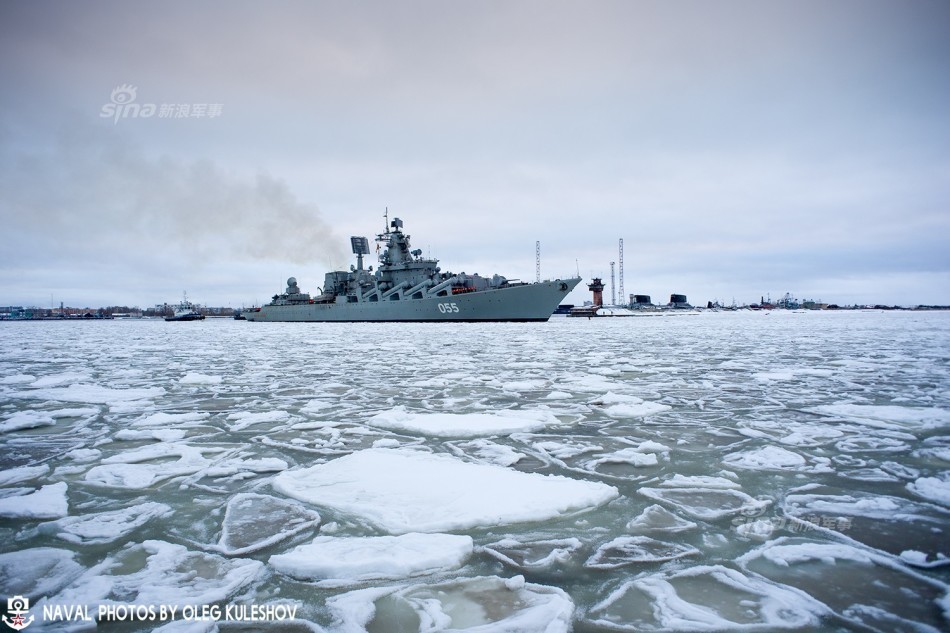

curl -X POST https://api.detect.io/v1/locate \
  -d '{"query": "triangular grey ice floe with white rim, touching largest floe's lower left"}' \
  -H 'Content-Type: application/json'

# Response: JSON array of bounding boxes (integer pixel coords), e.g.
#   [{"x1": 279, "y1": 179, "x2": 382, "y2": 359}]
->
[{"x1": 217, "y1": 493, "x2": 320, "y2": 556}]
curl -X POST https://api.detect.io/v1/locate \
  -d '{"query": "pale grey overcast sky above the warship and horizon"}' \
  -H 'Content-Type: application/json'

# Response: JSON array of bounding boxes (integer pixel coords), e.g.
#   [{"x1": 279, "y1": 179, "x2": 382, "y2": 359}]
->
[{"x1": 0, "y1": 0, "x2": 950, "y2": 307}]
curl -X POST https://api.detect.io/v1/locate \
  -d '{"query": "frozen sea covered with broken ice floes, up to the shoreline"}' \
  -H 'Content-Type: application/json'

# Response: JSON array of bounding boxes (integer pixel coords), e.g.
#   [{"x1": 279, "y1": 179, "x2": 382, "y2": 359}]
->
[{"x1": 0, "y1": 311, "x2": 950, "y2": 633}]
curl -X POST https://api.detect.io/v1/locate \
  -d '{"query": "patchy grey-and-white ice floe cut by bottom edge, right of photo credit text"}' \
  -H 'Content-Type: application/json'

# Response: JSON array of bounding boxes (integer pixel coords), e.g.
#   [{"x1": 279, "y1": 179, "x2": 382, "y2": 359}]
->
[{"x1": 327, "y1": 576, "x2": 574, "y2": 633}]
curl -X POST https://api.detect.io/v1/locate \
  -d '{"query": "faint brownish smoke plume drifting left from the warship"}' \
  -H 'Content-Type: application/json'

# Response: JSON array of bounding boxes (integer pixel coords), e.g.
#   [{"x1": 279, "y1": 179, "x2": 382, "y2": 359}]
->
[{"x1": 0, "y1": 127, "x2": 346, "y2": 265}]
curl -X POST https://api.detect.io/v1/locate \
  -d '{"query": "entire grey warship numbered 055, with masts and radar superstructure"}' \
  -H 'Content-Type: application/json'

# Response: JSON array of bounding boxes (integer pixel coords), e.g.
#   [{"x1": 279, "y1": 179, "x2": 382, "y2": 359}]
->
[{"x1": 242, "y1": 216, "x2": 580, "y2": 321}]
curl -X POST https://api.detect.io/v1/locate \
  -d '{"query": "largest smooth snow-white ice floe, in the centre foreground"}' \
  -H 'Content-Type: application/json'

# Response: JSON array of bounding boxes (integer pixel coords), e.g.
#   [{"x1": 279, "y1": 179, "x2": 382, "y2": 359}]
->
[{"x1": 273, "y1": 449, "x2": 619, "y2": 534}]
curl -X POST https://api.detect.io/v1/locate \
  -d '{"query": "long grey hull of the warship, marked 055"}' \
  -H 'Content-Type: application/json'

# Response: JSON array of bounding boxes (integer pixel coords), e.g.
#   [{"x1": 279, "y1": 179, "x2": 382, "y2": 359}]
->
[{"x1": 243, "y1": 277, "x2": 580, "y2": 322}]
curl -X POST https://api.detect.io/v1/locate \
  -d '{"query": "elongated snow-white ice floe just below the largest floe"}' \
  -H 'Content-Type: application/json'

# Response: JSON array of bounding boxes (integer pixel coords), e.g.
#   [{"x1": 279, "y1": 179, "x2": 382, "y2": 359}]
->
[{"x1": 268, "y1": 532, "x2": 474, "y2": 586}]
